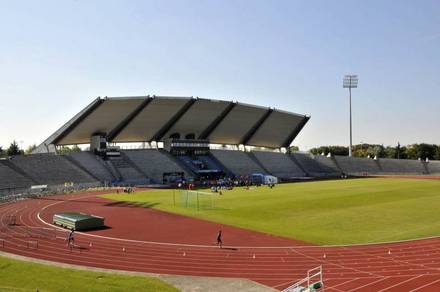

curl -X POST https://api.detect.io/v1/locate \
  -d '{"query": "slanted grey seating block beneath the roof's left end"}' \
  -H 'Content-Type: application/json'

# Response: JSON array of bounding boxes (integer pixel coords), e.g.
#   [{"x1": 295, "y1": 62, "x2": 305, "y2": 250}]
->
[{"x1": 67, "y1": 151, "x2": 116, "y2": 182}]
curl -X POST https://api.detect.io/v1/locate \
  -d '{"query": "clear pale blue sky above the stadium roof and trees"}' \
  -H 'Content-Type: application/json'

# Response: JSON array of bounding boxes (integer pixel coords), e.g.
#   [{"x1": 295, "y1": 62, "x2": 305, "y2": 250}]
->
[{"x1": 0, "y1": 0, "x2": 440, "y2": 150}]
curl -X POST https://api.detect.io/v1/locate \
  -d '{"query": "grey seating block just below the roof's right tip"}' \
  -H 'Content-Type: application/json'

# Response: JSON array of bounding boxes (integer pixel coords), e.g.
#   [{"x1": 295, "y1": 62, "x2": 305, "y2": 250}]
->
[{"x1": 291, "y1": 152, "x2": 341, "y2": 177}]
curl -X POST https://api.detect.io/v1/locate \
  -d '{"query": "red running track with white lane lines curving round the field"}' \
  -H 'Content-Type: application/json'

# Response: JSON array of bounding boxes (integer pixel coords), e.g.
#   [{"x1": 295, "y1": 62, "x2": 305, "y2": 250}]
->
[{"x1": 0, "y1": 192, "x2": 440, "y2": 291}]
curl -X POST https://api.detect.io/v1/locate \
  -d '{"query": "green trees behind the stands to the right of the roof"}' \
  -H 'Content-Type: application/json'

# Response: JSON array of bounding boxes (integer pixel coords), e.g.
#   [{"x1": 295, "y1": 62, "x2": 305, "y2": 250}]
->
[{"x1": 309, "y1": 143, "x2": 440, "y2": 160}]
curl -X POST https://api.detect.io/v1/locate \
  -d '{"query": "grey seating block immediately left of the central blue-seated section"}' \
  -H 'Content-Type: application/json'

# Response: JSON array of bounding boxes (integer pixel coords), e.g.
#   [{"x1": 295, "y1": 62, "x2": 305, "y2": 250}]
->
[{"x1": 123, "y1": 149, "x2": 192, "y2": 183}]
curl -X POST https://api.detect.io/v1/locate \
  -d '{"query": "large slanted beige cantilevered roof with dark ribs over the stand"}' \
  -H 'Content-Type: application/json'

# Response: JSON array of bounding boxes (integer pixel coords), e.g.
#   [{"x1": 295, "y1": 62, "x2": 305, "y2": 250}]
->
[{"x1": 39, "y1": 96, "x2": 309, "y2": 148}]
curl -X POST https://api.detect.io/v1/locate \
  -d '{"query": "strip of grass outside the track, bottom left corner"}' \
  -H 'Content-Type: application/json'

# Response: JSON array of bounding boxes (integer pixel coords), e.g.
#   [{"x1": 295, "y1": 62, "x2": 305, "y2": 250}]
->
[{"x1": 0, "y1": 257, "x2": 179, "y2": 292}]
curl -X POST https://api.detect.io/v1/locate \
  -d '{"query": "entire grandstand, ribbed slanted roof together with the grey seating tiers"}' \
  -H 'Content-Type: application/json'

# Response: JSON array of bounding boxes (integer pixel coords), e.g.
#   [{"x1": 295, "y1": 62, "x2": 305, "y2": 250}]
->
[{"x1": 0, "y1": 96, "x2": 440, "y2": 194}]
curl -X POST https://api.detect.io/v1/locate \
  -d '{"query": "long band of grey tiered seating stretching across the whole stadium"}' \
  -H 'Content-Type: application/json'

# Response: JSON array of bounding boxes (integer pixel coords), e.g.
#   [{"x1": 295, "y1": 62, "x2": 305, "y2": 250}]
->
[{"x1": 0, "y1": 149, "x2": 440, "y2": 192}]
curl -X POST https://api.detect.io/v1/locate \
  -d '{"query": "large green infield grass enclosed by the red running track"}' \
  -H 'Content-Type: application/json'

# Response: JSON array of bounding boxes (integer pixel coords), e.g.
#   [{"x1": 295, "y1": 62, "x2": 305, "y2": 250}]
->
[{"x1": 104, "y1": 178, "x2": 440, "y2": 244}]
